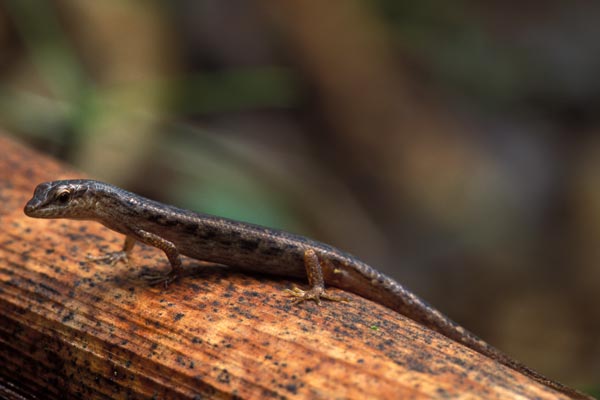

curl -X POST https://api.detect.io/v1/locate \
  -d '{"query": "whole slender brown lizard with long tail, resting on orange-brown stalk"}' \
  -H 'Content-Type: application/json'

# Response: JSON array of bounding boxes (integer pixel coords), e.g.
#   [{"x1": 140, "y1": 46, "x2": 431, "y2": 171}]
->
[{"x1": 25, "y1": 179, "x2": 591, "y2": 399}]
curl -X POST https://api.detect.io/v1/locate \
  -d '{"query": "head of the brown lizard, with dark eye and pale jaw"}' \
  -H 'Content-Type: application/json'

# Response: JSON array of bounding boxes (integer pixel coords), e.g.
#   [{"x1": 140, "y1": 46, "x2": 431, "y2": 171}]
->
[{"x1": 24, "y1": 179, "x2": 94, "y2": 219}]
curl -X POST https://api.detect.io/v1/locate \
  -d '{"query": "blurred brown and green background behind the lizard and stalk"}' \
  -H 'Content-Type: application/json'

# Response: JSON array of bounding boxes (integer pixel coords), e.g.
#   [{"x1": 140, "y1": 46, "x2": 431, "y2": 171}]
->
[{"x1": 0, "y1": 0, "x2": 600, "y2": 395}]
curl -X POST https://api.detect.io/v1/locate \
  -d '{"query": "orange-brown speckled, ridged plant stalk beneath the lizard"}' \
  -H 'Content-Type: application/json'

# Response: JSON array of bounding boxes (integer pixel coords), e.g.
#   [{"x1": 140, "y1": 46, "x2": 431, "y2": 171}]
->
[{"x1": 0, "y1": 136, "x2": 566, "y2": 399}]
